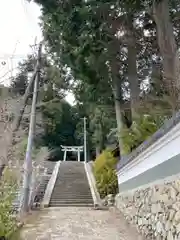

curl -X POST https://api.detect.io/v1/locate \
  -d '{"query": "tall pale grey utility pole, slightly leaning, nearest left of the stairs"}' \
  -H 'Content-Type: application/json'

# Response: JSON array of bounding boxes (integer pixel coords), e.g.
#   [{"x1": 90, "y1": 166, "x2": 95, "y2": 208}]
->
[{"x1": 21, "y1": 43, "x2": 42, "y2": 212}]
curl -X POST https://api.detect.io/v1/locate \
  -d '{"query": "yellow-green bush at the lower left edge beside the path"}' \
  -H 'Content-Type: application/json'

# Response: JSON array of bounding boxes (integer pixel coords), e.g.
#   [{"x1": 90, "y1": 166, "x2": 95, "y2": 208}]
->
[{"x1": 0, "y1": 169, "x2": 17, "y2": 237}]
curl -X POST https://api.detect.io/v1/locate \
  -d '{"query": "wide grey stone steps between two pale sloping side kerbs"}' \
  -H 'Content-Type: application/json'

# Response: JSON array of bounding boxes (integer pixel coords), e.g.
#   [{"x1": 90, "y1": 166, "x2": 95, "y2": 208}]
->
[{"x1": 49, "y1": 161, "x2": 93, "y2": 207}]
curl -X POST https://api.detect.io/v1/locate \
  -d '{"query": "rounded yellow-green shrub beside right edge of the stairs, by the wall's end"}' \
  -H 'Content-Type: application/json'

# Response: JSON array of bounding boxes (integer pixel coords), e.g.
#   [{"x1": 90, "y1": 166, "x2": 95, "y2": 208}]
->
[{"x1": 93, "y1": 150, "x2": 118, "y2": 198}]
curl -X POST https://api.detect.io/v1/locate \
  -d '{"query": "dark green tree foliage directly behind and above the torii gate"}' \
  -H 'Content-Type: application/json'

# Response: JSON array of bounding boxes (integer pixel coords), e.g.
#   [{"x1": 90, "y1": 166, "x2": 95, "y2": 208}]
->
[{"x1": 42, "y1": 96, "x2": 79, "y2": 148}]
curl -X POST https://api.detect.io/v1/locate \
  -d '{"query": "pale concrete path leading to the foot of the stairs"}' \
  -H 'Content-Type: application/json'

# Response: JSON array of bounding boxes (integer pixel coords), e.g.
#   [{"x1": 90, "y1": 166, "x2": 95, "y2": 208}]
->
[{"x1": 21, "y1": 207, "x2": 142, "y2": 240}]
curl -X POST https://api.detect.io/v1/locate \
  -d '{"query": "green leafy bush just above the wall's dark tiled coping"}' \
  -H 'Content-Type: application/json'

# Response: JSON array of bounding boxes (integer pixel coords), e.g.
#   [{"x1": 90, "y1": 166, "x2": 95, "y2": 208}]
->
[{"x1": 121, "y1": 115, "x2": 160, "y2": 155}]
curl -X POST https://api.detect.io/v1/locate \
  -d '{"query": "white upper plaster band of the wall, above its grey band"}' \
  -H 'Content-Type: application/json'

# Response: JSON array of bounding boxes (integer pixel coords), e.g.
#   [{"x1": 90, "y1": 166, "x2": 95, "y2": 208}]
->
[{"x1": 117, "y1": 123, "x2": 180, "y2": 184}]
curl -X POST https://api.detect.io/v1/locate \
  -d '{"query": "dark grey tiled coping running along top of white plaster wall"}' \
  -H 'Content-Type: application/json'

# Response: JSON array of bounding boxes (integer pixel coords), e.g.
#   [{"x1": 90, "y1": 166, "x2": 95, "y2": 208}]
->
[{"x1": 117, "y1": 111, "x2": 180, "y2": 171}]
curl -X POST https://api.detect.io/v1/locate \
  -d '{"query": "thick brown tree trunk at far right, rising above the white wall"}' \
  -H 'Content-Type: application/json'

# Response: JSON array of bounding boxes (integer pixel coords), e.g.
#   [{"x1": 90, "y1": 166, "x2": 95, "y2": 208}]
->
[{"x1": 153, "y1": 0, "x2": 179, "y2": 111}]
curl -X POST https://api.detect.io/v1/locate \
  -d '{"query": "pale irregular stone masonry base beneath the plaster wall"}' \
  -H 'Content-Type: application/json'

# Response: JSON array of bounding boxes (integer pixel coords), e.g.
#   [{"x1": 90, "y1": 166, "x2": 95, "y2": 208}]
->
[{"x1": 115, "y1": 176, "x2": 180, "y2": 240}]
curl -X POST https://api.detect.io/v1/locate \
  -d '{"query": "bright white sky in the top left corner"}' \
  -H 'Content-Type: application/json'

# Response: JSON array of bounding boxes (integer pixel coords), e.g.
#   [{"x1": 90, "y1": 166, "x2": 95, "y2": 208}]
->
[{"x1": 0, "y1": 0, "x2": 42, "y2": 83}]
